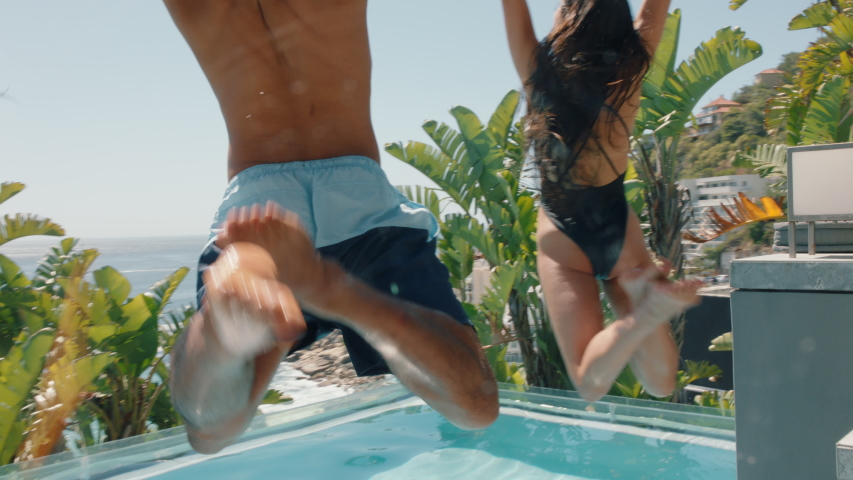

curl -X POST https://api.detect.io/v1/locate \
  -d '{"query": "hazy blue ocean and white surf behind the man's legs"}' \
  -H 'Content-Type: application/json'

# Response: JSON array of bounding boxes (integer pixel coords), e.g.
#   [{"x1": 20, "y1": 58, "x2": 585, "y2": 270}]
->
[{"x1": 0, "y1": 235, "x2": 347, "y2": 406}]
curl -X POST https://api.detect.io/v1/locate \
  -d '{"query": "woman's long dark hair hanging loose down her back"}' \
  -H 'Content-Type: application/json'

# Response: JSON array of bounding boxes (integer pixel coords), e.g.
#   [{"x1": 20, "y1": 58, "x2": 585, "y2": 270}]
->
[{"x1": 526, "y1": 0, "x2": 650, "y2": 190}]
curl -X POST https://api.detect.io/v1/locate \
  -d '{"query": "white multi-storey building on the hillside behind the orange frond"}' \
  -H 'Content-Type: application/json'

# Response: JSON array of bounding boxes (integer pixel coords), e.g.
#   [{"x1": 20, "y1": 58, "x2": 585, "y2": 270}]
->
[{"x1": 678, "y1": 175, "x2": 773, "y2": 259}]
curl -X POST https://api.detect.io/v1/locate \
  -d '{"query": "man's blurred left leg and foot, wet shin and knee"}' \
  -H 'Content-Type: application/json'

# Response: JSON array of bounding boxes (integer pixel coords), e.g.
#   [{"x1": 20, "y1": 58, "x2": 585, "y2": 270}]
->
[{"x1": 171, "y1": 242, "x2": 305, "y2": 453}]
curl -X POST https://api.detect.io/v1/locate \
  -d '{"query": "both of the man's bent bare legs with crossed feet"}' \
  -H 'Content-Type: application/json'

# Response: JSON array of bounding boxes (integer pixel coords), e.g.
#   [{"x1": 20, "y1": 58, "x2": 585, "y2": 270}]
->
[{"x1": 172, "y1": 206, "x2": 498, "y2": 453}]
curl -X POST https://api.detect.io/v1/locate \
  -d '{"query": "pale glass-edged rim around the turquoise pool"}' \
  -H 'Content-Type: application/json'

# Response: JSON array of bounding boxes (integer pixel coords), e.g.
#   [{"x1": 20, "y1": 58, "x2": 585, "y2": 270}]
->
[{"x1": 0, "y1": 384, "x2": 734, "y2": 480}]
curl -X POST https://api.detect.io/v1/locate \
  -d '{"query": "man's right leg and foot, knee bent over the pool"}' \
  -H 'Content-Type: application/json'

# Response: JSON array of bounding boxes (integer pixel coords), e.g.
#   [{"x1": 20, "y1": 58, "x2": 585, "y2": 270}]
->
[{"x1": 220, "y1": 204, "x2": 498, "y2": 429}]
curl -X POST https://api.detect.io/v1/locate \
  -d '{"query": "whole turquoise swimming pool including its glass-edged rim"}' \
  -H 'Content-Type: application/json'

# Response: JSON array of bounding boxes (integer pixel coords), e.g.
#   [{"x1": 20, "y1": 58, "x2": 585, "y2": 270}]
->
[{"x1": 0, "y1": 385, "x2": 736, "y2": 480}]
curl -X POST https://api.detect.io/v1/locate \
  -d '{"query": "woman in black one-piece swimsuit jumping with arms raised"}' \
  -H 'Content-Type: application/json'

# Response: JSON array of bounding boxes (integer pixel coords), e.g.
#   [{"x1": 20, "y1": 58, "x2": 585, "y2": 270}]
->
[{"x1": 503, "y1": 0, "x2": 701, "y2": 401}]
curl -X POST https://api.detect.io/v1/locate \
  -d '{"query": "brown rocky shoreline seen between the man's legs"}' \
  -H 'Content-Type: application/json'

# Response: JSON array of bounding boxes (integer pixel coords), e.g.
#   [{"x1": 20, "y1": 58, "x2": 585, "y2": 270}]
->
[{"x1": 285, "y1": 330, "x2": 393, "y2": 391}]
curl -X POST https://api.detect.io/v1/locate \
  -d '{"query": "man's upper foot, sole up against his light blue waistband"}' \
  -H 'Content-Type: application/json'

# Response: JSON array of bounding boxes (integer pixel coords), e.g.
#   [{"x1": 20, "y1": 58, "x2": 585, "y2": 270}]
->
[{"x1": 216, "y1": 202, "x2": 323, "y2": 302}]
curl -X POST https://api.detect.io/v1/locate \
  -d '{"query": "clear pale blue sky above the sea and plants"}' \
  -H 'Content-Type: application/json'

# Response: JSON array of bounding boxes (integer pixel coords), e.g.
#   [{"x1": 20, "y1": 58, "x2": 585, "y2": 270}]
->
[{"x1": 0, "y1": 0, "x2": 817, "y2": 239}]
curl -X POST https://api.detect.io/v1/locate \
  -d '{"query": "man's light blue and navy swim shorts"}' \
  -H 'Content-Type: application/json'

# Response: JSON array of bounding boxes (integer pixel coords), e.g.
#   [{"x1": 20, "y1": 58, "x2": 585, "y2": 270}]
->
[{"x1": 197, "y1": 156, "x2": 471, "y2": 376}]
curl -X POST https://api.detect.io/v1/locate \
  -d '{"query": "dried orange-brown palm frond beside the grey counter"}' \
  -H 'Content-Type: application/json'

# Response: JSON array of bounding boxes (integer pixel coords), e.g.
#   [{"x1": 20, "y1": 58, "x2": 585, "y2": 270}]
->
[{"x1": 681, "y1": 192, "x2": 785, "y2": 243}]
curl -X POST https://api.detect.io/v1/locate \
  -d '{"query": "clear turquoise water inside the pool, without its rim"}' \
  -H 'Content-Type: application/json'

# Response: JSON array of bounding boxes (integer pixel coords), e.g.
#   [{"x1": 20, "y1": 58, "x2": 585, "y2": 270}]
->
[{"x1": 118, "y1": 401, "x2": 736, "y2": 480}]
